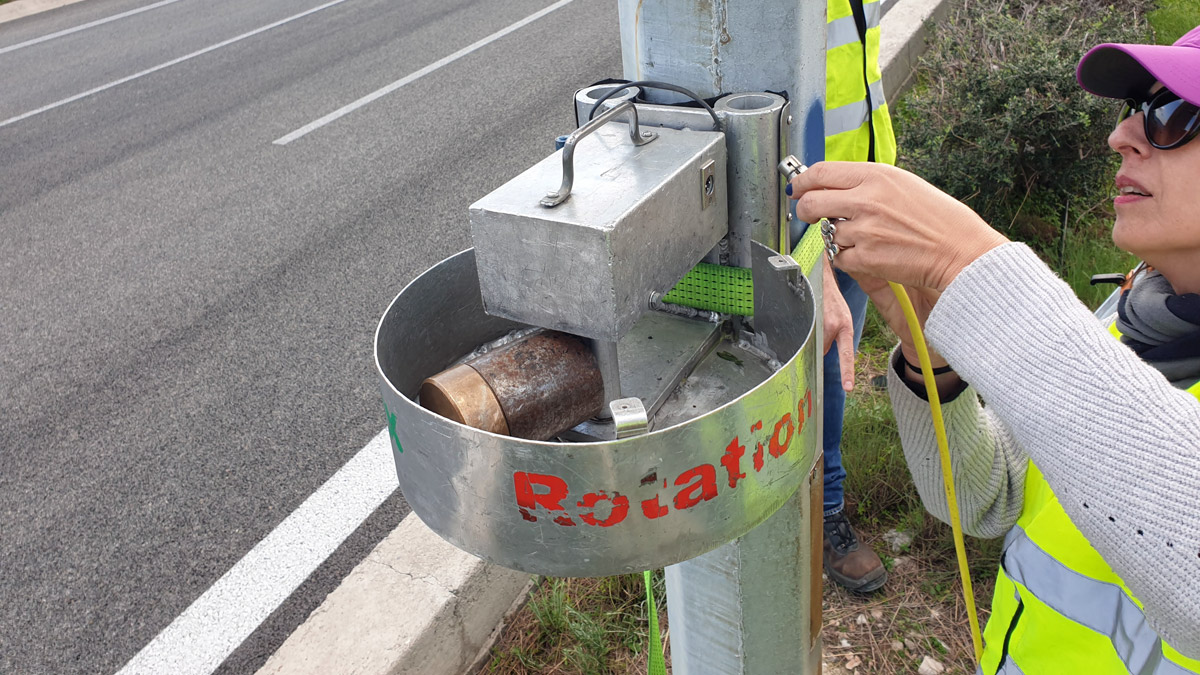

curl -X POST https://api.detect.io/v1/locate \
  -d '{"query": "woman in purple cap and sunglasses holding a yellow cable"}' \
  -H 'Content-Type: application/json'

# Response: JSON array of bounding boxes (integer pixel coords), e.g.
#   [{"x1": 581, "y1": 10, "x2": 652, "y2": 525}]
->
[{"x1": 790, "y1": 26, "x2": 1200, "y2": 675}]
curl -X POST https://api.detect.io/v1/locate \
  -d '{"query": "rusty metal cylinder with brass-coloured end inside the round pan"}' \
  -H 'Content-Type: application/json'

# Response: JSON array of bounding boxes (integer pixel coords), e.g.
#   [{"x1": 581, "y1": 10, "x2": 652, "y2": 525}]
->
[{"x1": 420, "y1": 330, "x2": 605, "y2": 441}]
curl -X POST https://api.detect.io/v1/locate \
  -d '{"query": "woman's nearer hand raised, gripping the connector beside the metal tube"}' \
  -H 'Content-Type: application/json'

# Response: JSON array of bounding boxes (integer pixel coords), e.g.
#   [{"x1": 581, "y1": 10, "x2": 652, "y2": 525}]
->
[{"x1": 791, "y1": 162, "x2": 1008, "y2": 292}]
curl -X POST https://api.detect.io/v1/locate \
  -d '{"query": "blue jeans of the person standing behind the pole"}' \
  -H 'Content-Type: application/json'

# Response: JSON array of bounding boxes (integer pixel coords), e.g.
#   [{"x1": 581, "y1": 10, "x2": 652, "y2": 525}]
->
[{"x1": 822, "y1": 269, "x2": 866, "y2": 515}]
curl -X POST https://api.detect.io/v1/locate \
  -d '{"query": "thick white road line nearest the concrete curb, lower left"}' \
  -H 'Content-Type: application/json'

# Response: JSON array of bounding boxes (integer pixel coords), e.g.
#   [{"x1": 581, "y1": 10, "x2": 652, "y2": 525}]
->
[{"x1": 116, "y1": 429, "x2": 397, "y2": 675}]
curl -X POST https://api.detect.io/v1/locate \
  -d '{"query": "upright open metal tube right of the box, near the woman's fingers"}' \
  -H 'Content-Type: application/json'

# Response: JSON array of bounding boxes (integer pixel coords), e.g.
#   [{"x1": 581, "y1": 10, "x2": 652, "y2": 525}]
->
[{"x1": 715, "y1": 92, "x2": 787, "y2": 267}]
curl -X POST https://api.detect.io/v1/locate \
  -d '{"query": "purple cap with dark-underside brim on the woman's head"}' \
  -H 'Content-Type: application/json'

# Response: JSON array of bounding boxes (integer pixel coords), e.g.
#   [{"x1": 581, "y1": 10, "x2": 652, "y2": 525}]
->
[{"x1": 1075, "y1": 26, "x2": 1200, "y2": 106}]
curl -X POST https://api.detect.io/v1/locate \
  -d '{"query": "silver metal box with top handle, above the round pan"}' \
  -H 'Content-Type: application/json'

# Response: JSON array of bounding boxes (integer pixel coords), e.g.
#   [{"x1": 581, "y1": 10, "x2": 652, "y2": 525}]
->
[{"x1": 470, "y1": 118, "x2": 728, "y2": 342}]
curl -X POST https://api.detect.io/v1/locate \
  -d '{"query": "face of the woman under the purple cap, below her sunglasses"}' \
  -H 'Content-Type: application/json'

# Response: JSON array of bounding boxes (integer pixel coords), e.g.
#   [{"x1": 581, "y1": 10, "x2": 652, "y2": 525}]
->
[{"x1": 1109, "y1": 84, "x2": 1200, "y2": 293}]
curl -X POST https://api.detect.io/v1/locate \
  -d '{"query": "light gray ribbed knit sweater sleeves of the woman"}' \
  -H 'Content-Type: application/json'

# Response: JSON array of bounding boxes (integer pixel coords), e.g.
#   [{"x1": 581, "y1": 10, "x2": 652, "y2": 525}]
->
[{"x1": 888, "y1": 244, "x2": 1200, "y2": 658}]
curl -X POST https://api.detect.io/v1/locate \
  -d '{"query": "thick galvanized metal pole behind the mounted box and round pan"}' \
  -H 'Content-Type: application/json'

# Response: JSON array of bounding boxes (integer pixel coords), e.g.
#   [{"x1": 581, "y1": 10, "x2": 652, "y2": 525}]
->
[{"x1": 618, "y1": 0, "x2": 826, "y2": 675}]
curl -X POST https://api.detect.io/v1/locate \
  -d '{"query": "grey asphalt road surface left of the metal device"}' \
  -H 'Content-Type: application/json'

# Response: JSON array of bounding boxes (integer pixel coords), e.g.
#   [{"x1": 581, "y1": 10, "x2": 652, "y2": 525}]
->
[{"x1": 0, "y1": 0, "x2": 620, "y2": 674}]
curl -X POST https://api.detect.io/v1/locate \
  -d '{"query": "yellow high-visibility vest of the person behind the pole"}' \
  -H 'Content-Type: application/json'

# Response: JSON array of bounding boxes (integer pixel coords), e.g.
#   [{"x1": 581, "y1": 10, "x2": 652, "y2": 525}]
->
[{"x1": 824, "y1": 0, "x2": 896, "y2": 165}]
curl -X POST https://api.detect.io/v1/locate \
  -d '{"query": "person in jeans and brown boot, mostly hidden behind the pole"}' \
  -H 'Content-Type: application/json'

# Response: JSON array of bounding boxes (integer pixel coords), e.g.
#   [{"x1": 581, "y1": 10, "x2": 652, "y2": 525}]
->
[{"x1": 816, "y1": 0, "x2": 896, "y2": 593}]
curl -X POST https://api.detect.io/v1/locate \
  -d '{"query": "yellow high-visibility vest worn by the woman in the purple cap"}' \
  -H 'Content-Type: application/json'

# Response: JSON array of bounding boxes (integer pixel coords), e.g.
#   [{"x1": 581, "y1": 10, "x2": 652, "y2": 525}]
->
[{"x1": 980, "y1": 322, "x2": 1200, "y2": 675}]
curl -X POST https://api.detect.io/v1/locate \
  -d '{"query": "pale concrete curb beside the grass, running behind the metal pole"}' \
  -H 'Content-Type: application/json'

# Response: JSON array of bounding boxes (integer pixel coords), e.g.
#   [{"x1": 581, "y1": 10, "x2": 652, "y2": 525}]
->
[{"x1": 259, "y1": 0, "x2": 948, "y2": 675}]
